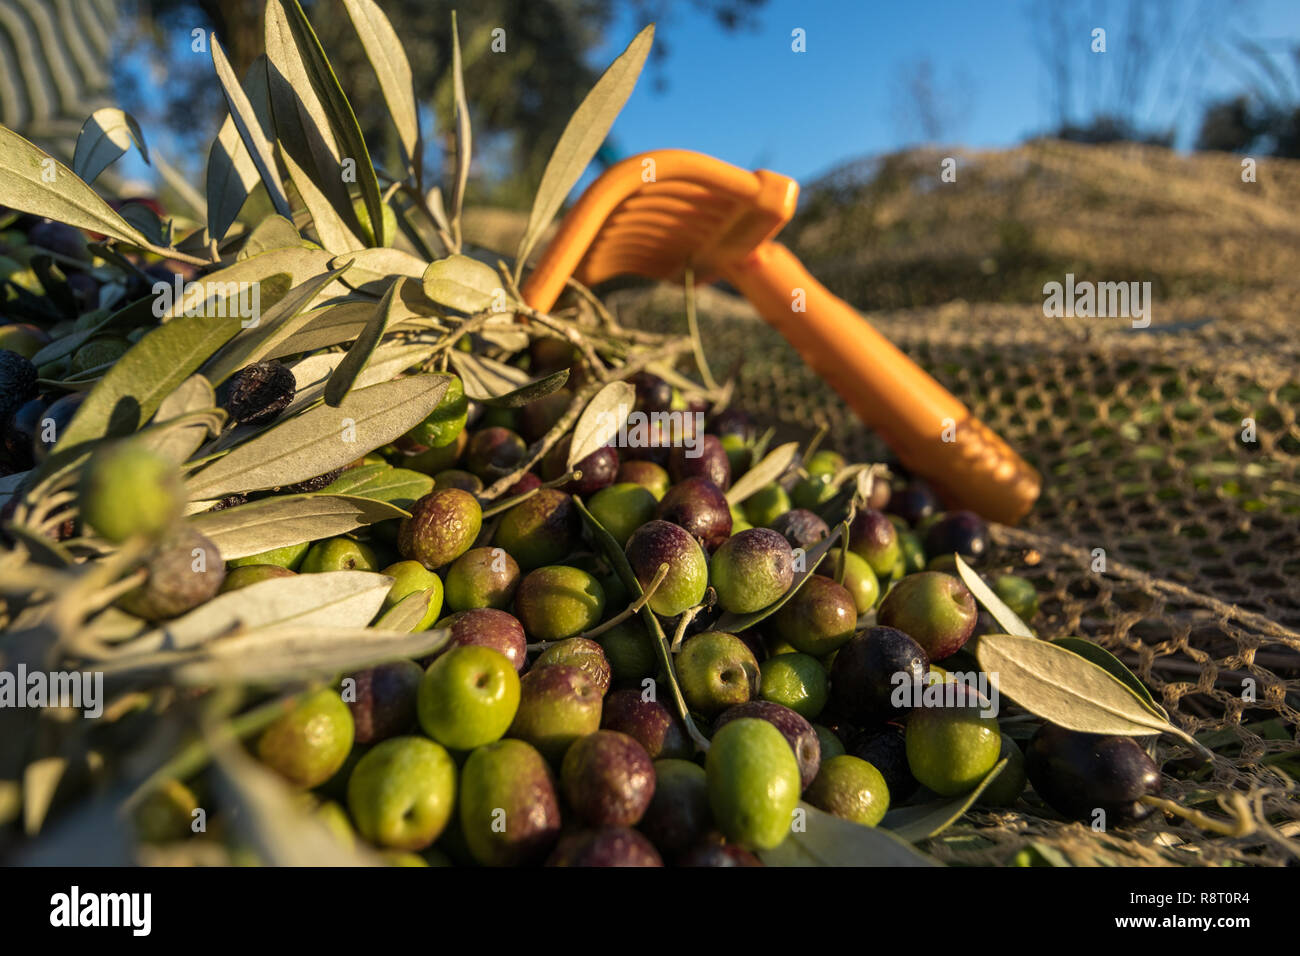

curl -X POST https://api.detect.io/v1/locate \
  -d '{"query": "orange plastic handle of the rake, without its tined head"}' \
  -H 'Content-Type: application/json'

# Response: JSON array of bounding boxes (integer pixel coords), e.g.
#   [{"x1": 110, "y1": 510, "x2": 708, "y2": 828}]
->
[{"x1": 723, "y1": 242, "x2": 1043, "y2": 524}]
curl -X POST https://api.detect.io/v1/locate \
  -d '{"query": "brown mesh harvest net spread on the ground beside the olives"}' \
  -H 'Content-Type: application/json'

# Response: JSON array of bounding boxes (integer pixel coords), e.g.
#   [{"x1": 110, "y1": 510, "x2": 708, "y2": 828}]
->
[{"x1": 611, "y1": 277, "x2": 1300, "y2": 865}]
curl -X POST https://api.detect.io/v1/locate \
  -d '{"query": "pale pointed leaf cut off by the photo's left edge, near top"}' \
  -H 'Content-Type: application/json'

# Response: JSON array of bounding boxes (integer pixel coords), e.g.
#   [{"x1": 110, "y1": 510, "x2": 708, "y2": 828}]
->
[{"x1": 0, "y1": 126, "x2": 150, "y2": 247}]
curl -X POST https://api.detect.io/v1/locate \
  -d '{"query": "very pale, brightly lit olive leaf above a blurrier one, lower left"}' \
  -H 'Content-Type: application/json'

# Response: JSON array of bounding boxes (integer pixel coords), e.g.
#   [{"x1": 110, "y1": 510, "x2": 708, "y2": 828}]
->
[{"x1": 125, "y1": 572, "x2": 393, "y2": 655}]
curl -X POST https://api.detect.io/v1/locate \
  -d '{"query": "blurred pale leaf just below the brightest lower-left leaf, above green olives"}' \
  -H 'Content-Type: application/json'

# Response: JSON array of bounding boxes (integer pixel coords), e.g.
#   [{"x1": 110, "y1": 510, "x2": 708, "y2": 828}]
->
[{"x1": 172, "y1": 624, "x2": 451, "y2": 685}]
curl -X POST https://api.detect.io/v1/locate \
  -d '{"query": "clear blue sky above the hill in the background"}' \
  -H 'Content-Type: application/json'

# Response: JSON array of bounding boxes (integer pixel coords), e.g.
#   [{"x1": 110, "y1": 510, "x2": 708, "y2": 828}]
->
[{"x1": 599, "y1": 0, "x2": 1300, "y2": 181}]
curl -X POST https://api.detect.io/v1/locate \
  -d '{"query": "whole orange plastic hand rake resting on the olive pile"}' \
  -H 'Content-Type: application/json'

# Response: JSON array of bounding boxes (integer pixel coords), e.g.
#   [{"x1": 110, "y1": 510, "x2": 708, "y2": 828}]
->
[{"x1": 523, "y1": 150, "x2": 1041, "y2": 524}]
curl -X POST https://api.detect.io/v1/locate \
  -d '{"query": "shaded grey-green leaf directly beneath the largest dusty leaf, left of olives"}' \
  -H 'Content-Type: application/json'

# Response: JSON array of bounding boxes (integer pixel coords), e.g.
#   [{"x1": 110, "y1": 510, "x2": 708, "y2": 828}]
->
[{"x1": 190, "y1": 494, "x2": 405, "y2": 561}]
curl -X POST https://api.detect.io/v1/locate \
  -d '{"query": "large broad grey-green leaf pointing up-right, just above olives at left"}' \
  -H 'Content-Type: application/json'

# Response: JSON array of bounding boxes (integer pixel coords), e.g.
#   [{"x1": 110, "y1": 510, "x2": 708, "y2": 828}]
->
[{"x1": 187, "y1": 375, "x2": 450, "y2": 499}]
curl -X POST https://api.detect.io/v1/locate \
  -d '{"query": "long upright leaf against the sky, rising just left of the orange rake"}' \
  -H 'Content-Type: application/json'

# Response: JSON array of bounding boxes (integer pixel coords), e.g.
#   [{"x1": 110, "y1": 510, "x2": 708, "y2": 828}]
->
[{"x1": 515, "y1": 23, "x2": 654, "y2": 278}]
